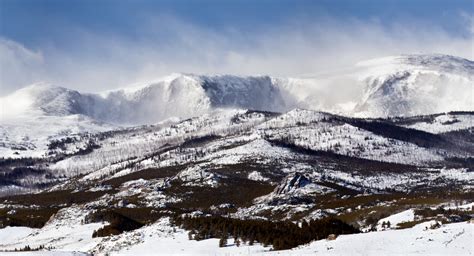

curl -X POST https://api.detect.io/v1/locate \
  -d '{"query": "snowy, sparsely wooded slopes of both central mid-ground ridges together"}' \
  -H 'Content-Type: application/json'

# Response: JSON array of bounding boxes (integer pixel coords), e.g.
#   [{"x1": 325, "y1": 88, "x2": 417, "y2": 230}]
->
[{"x1": 43, "y1": 109, "x2": 462, "y2": 185}]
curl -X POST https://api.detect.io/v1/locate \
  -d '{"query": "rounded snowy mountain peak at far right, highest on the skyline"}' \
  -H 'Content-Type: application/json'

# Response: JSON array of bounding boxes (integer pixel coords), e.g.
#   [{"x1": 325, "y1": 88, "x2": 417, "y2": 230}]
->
[{"x1": 355, "y1": 54, "x2": 474, "y2": 117}]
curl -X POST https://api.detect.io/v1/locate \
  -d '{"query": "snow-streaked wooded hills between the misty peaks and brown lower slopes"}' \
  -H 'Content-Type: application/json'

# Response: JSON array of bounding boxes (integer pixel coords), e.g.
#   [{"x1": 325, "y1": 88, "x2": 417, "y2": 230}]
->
[{"x1": 0, "y1": 109, "x2": 474, "y2": 194}]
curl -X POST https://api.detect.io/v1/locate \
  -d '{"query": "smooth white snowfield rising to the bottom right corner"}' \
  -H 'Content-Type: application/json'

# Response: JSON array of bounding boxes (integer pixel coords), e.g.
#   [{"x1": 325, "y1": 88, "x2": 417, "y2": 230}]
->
[{"x1": 269, "y1": 222, "x2": 474, "y2": 256}]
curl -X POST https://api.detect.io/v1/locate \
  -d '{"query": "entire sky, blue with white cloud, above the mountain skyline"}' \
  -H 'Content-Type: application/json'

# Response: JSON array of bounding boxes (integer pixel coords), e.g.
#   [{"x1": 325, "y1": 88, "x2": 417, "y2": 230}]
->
[{"x1": 0, "y1": 0, "x2": 474, "y2": 94}]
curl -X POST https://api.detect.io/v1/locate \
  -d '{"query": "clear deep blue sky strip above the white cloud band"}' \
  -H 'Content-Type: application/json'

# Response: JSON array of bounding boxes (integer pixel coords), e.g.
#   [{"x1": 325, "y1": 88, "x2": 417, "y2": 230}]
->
[{"x1": 0, "y1": 0, "x2": 473, "y2": 48}]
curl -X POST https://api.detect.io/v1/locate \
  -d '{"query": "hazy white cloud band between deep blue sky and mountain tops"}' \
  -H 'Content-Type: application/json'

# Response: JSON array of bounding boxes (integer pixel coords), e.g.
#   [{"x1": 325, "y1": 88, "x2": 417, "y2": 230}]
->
[{"x1": 0, "y1": 14, "x2": 474, "y2": 94}]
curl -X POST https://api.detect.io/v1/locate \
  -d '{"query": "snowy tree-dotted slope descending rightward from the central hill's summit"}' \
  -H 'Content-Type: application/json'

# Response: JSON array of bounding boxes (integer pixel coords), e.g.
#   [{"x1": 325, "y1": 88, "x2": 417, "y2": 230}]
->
[{"x1": 258, "y1": 109, "x2": 443, "y2": 164}]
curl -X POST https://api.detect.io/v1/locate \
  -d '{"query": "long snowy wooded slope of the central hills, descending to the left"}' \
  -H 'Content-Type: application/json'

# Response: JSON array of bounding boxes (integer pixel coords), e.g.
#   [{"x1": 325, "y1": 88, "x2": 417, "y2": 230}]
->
[{"x1": 51, "y1": 109, "x2": 265, "y2": 179}]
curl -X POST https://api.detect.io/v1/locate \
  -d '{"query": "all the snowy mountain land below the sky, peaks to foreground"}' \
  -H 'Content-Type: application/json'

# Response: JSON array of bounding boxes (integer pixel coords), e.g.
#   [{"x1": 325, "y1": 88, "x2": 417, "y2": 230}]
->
[{"x1": 0, "y1": 54, "x2": 474, "y2": 255}]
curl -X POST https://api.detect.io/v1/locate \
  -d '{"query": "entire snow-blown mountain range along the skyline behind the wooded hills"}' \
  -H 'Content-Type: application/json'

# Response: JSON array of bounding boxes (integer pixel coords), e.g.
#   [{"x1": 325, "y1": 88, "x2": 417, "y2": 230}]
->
[{"x1": 0, "y1": 55, "x2": 474, "y2": 124}]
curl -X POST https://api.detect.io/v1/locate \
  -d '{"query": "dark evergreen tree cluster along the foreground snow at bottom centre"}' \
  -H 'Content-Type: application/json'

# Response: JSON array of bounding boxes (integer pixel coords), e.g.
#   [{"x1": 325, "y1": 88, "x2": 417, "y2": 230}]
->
[{"x1": 174, "y1": 216, "x2": 360, "y2": 250}]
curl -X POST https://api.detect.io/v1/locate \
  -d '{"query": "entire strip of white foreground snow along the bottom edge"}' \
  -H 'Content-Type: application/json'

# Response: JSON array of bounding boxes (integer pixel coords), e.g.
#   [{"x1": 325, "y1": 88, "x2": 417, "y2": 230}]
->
[{"x1": 0, "y1": 219, "x2": 474, "y2": 256}]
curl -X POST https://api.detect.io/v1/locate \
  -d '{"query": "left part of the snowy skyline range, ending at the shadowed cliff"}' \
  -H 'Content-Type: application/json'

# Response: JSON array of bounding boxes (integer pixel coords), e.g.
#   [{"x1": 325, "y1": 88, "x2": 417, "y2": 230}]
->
[{"x1": 0, "y1": 74, "x2": 291, "y2": 124}]
